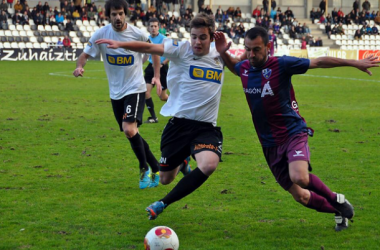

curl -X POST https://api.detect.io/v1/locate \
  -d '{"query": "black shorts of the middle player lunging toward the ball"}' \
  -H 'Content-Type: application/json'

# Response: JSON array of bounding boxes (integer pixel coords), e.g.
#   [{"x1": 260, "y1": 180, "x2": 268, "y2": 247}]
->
[{"x1": 160, "y1": 117, "x2": 223, "y2": 172}]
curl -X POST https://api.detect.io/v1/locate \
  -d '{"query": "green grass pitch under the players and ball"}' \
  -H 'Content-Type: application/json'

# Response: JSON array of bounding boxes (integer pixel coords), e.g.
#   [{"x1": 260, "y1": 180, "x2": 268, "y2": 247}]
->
[{"x1": 0, "y1": 61, "x2": 380, "y2": 250}]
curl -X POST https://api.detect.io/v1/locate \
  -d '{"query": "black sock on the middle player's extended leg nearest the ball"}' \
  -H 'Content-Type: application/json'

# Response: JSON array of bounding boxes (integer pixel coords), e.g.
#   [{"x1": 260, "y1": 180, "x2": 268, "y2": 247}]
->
[{"x1": 160, "y1": 168, "x2": 208, "y2": 206}]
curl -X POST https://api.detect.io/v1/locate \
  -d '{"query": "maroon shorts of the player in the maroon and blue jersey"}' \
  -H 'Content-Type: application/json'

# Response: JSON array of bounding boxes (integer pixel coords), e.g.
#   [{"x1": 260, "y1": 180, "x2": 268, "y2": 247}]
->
[{"x1": 263, "y1": 133, "x2": 310, "y2": 190}]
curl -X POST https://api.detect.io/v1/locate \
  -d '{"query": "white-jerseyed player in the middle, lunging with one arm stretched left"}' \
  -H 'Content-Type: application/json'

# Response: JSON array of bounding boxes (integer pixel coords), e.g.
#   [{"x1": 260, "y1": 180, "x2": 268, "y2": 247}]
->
[{"x1": 96, "y1": 13, "x2": 224, "y2": 220}]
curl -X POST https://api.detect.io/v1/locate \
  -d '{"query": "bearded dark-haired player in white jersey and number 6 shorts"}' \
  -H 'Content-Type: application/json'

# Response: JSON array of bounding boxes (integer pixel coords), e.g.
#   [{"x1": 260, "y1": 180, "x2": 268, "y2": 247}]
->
[{"x1": 73, "y1": 0, "x2": 161, "y2": 189}]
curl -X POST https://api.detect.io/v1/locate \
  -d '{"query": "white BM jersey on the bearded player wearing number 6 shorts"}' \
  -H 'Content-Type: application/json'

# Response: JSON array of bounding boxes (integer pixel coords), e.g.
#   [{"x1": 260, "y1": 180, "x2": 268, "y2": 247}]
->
[{"x1": 84, "y1": 24, "x2": 149, "y2": 100}]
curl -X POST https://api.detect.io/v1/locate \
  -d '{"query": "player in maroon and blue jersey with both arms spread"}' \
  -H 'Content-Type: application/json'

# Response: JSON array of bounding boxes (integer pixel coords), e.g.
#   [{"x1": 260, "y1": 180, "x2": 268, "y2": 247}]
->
[{"x1": 215, "y1": 27, "x2": 379, "y2": 231}]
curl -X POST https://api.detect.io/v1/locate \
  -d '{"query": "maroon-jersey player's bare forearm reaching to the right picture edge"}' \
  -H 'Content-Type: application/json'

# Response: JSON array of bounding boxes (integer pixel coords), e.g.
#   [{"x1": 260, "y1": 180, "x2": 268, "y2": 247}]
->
[{"x1": 309, "y1": 56, "x2": 380, "y2": 76}]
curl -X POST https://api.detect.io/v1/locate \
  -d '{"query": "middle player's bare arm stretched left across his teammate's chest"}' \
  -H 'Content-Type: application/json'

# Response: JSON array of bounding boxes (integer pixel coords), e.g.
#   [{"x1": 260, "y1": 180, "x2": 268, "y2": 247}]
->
[{"x1": 95, "y1": 39, "x2": 164, "y2": 56}]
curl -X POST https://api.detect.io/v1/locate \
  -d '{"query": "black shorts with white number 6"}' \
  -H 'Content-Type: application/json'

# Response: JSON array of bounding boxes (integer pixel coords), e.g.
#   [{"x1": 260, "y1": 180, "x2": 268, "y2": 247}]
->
[{"x1": 111, "y1": 92, "x2": 145, "y2": 131}]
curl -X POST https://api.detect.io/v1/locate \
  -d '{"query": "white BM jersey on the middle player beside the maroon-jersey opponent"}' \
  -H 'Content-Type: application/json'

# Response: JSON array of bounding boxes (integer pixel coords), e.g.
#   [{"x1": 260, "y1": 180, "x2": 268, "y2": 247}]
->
[{"x1": 161, "y1": 39, "x2": 224, "y2": 126}]
